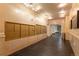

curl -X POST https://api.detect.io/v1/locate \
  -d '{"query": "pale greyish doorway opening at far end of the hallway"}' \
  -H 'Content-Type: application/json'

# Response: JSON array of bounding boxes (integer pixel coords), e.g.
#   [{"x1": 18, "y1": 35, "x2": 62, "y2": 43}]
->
[{"x1": 51, "y1": 24, "x2": 62, "y2": 41}]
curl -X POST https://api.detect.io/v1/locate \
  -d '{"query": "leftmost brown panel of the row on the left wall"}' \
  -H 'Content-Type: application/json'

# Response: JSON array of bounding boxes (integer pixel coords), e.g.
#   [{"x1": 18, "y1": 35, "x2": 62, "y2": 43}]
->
[{"x1": 5, "y1": 22, "x2": 15, "y2": 41}]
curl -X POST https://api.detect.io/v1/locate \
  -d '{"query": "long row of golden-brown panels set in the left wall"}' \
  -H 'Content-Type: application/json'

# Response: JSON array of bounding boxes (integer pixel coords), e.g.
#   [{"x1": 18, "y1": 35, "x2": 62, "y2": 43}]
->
[{"x1": 5, "y1": 22, "x2": 47, "y2": 41}]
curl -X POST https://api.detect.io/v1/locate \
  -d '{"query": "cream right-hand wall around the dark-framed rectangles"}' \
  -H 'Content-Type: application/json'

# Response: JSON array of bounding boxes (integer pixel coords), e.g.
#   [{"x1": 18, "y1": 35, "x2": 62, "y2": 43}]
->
[{"x1": 65, "y1": 3, "x2": 79, "y2": 55}]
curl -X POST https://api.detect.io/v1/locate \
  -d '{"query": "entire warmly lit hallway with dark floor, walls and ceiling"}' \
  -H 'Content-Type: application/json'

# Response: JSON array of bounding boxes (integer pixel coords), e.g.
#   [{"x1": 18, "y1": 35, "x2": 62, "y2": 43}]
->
[{"x1": 0, "y1": 3, "x2": 79, "y2": 56}]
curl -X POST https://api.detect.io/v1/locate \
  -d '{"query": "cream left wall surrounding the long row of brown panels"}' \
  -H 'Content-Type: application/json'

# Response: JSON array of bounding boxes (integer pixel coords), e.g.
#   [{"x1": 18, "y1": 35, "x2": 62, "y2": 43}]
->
[{"x1": 0, "y1": 4, "x2": 47, "y2": 55}]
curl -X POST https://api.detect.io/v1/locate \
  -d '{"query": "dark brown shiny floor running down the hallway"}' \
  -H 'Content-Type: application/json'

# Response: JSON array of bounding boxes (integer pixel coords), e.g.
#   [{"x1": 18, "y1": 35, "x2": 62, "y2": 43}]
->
[{"x1": 10, "y1": 33, "x2": 74, "y2": 56}]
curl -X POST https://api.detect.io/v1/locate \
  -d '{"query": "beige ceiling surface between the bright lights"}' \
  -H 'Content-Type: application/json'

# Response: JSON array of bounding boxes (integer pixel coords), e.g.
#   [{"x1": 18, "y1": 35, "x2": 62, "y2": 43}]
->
[{"x1": 32, "y1": 3, "x2": 72, "y2": 19}]
